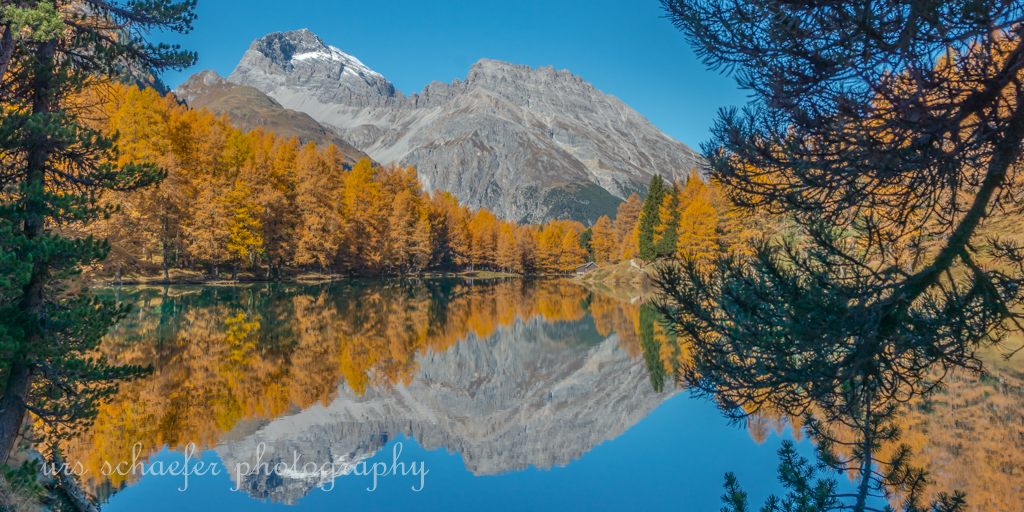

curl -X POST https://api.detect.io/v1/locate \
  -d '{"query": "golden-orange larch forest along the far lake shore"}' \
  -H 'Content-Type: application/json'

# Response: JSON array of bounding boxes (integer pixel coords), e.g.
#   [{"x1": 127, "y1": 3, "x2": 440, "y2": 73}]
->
[{"x1": 83, "y1": 85, "x2": 761, "y2": 276}]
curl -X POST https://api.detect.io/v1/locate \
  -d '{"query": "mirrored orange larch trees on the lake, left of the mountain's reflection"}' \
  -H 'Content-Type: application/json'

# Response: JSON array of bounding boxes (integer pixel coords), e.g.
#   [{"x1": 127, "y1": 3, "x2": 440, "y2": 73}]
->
[{"x1": 69, "y1": 280, "x2": 642, "y2": 498}]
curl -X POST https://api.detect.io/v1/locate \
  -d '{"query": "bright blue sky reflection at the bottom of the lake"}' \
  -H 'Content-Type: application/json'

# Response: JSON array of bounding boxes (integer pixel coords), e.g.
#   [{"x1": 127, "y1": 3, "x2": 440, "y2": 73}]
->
[{"x1": 103, "y1": 395, "x2": 812, "y2": 512}]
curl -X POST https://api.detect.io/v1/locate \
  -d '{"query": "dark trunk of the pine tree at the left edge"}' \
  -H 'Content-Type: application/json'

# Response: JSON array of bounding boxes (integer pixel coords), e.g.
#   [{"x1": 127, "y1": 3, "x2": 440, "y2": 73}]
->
[{"x1": 0, "y1": 40, "x2": 56, "y2": 462}]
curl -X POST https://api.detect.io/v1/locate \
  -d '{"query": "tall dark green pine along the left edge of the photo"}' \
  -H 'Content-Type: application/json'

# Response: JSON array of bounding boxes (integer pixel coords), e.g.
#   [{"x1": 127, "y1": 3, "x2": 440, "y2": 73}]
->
[{"x1": 0, "y1": 0, "x2": 196, "y2": 463}]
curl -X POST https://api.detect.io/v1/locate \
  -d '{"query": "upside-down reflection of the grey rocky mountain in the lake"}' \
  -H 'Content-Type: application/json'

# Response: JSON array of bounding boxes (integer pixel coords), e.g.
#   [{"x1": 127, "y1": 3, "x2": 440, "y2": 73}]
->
[{"x1": 217, "y1": 318, "x2": 675, "y2": 503}]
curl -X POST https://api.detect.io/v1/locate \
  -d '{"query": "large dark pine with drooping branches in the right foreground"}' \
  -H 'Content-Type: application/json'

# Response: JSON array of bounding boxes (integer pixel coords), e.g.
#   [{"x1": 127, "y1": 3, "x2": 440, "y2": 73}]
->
[{"x1": 659, "y1": 0, "x2": 1024, "y2": 512}]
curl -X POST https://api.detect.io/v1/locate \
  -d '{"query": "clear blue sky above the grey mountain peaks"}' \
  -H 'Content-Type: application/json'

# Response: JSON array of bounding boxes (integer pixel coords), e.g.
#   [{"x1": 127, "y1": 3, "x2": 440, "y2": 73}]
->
[{"x1": 155, "y1": 0, "x2": 746, "y2": 150}]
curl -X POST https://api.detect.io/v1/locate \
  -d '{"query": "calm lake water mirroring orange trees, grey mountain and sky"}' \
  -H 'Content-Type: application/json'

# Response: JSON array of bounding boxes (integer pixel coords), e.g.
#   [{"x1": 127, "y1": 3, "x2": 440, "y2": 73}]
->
[{"x1": 69, "y1": 280, "x2": 1024, "y2": 511}]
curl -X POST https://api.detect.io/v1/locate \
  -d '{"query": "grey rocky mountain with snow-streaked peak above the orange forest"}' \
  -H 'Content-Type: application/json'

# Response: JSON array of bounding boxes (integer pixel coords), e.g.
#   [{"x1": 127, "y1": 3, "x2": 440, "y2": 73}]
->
[{"x1": 228, "y1": 30, "x2": 703, "y2": 222}]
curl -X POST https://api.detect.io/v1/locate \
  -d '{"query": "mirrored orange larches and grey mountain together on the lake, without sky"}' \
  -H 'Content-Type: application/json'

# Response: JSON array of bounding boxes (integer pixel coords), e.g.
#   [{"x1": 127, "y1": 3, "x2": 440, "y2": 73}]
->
[{"x1": 72, "y1": 280, "x2": 675, "y2": 503}]
